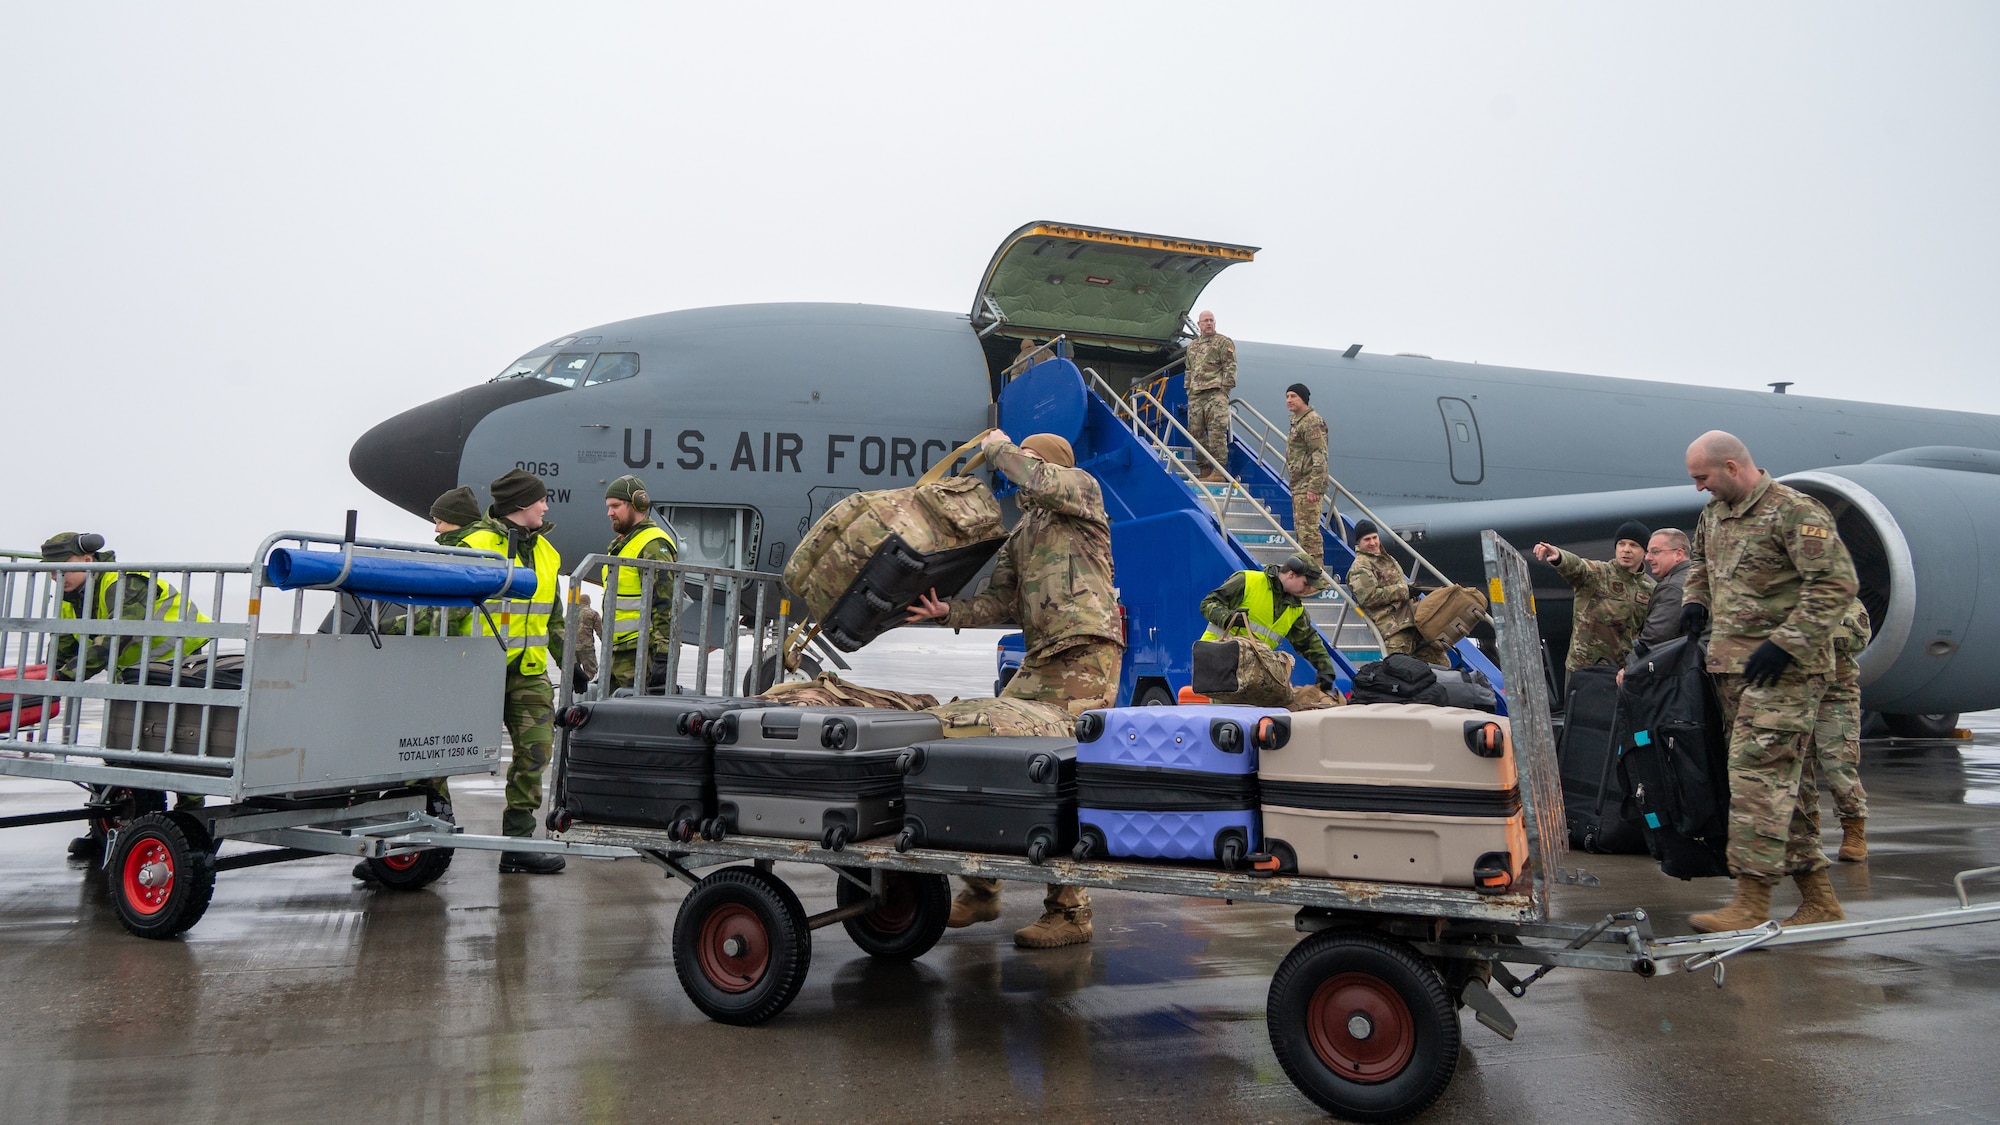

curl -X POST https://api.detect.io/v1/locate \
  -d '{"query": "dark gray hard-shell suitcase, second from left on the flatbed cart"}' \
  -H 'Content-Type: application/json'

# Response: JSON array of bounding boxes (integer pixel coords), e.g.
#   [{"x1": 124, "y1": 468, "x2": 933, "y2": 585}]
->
[{"x1": 716, "y1": 707, "x2": 944, "y2": 851}]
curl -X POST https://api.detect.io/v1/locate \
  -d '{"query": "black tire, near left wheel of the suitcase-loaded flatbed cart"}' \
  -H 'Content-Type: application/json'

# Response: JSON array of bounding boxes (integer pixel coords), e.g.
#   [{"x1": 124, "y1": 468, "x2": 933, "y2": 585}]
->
[{"x1": 674, "y1": 867, "x2": 812, "y2": 1027}]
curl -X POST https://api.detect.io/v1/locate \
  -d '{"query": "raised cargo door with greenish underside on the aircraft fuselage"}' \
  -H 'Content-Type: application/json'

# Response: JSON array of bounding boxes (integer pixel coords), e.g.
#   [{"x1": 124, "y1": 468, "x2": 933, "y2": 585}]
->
[{"x1": 972, "y1": 222, "x2": 1258, "y2": 350}]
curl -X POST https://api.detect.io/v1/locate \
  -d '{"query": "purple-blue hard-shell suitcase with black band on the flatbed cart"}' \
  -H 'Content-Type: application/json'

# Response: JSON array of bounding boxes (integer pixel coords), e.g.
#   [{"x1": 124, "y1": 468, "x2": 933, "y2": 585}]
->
[{"x1": 1072, "y1": 705, "x2": 1284, "y2": 867}]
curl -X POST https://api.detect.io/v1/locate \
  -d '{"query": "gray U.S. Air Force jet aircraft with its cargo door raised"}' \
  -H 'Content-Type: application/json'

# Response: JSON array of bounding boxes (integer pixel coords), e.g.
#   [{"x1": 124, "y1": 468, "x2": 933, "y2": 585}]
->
[{"x1": 348, "y1": 222, "x2": 2000, "y2": 735}]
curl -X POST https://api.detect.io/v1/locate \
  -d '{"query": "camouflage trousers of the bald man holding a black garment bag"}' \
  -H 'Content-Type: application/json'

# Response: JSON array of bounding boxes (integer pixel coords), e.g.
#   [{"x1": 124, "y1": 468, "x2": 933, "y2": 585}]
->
[{"x1": 1716, "y1": 667, "x2": 1826, "y2": 883}]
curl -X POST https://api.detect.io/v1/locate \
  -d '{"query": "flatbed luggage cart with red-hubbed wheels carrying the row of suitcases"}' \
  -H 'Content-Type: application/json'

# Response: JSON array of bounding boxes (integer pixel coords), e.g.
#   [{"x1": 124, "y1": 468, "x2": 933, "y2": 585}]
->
[{"x1": 556, "y1": 532, "x2": 2000, "y2": 1121}]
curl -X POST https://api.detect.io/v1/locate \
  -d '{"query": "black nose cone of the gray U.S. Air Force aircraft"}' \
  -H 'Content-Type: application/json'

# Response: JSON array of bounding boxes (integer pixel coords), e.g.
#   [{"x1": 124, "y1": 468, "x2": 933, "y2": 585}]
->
[{"x1": 348, "y1": 378, "x2": 564, "y2": 518}]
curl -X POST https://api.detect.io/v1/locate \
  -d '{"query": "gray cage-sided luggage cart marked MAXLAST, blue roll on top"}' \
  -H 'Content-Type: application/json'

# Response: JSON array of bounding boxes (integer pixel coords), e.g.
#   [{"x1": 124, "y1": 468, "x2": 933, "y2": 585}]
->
[{"x1": 0, "y1": 512, "x2": 632, "y2": 937}]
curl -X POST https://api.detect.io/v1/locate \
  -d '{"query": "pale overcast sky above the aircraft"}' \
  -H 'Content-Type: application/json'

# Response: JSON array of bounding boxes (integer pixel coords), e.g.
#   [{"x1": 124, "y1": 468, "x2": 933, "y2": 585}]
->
[{"x1": 0, "y1": 2, "x2": 2000, "y2": 560}]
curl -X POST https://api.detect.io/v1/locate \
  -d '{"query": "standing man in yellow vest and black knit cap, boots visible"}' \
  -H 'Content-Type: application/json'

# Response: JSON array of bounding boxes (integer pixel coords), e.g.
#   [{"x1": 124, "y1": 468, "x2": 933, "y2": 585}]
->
[{"x1": 464, "y1": 468, "x2": 564, "y2": 875}]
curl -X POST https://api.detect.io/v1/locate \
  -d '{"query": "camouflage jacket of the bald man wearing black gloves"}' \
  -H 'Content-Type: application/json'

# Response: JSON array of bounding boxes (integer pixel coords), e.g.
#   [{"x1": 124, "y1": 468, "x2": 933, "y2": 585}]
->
[{"x1": 1682, "y1": 472, "x2": 1860, "y2": 675}]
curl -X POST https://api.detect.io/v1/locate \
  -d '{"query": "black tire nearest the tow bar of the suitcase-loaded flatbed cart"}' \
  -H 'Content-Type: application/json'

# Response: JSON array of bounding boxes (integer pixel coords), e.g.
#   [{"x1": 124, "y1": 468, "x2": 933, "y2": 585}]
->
[{"x1": 1264, "y1": 931, "x2": 1460, "y2": 1121}]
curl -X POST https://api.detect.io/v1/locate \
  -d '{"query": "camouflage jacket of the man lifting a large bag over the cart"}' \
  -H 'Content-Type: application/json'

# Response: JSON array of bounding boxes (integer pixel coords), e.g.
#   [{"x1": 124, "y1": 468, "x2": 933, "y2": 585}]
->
[{"x1": 944, "y1": 444, "x2": 1120, "y2": 659}]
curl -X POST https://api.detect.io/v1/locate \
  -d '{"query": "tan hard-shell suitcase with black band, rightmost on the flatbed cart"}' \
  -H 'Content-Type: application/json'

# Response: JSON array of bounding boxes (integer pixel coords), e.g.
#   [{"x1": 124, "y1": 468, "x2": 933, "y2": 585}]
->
[{"x1": 1258, "y1": 703, "x2": 1528, "y2": 893}]
